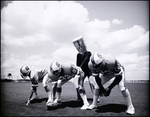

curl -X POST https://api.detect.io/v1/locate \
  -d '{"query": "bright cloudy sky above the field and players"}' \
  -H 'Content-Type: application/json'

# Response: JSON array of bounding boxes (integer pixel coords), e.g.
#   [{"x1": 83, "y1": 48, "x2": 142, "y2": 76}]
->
[{"x1": 1, "y1": 1, "x2": 149, "y2": 80}]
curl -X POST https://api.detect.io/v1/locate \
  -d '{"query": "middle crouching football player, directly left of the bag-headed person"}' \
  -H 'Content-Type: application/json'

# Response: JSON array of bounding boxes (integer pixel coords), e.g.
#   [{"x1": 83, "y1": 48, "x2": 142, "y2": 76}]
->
[{"x1": 43, "y1": 61, "x2": 89, "y2": 109}]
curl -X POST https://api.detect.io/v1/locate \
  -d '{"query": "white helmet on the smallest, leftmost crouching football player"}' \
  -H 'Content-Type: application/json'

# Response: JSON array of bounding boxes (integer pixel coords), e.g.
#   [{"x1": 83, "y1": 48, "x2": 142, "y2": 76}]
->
[{"x1": 20, "y1": 65, "x2": 31, "y2": 78}]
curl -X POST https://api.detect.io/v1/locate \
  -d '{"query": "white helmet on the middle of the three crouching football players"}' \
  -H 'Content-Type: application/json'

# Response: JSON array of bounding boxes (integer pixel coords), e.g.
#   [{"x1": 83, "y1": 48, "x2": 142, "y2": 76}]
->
[{"x1": 50, "y1": 61, "x2": 62, "y2": 76}]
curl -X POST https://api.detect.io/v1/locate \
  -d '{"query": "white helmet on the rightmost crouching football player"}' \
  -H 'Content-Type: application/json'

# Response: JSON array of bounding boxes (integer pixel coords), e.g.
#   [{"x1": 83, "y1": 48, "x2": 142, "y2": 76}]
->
[{"x1": 91, "y1": 52, "x2": 103, "y2": 66}]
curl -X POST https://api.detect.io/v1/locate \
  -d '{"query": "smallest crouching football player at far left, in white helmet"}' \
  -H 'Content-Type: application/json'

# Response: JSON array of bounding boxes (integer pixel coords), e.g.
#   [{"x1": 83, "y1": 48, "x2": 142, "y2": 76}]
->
[{"x1": 20, "y1": 65, "x2": 48, "y2": 105}]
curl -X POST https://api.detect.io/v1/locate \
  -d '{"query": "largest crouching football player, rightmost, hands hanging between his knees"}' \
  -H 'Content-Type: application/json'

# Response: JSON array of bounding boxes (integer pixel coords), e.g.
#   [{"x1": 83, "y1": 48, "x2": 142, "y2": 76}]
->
[{"x1": 88, "y1": 53, "x2": 135, "y2": 114}]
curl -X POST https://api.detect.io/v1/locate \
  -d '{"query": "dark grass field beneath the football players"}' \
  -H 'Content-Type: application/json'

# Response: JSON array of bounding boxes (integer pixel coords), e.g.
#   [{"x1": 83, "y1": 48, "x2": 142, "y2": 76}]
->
[{"x1": 1, "y1": 82, "x2": 149, "y2": 116}]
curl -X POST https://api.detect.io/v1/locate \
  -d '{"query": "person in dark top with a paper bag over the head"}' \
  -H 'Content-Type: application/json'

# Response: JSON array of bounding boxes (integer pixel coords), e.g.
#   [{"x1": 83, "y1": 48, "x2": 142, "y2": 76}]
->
[{"x1": 73, "y1": 36, "x2": 94, "y2": 100}]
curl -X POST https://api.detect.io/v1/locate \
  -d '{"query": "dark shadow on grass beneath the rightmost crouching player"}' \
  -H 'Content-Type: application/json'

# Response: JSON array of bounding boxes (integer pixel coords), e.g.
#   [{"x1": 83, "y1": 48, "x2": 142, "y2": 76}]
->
[{"x1": 95, "y1": 104, "x2": 127, "y2": 113}]
